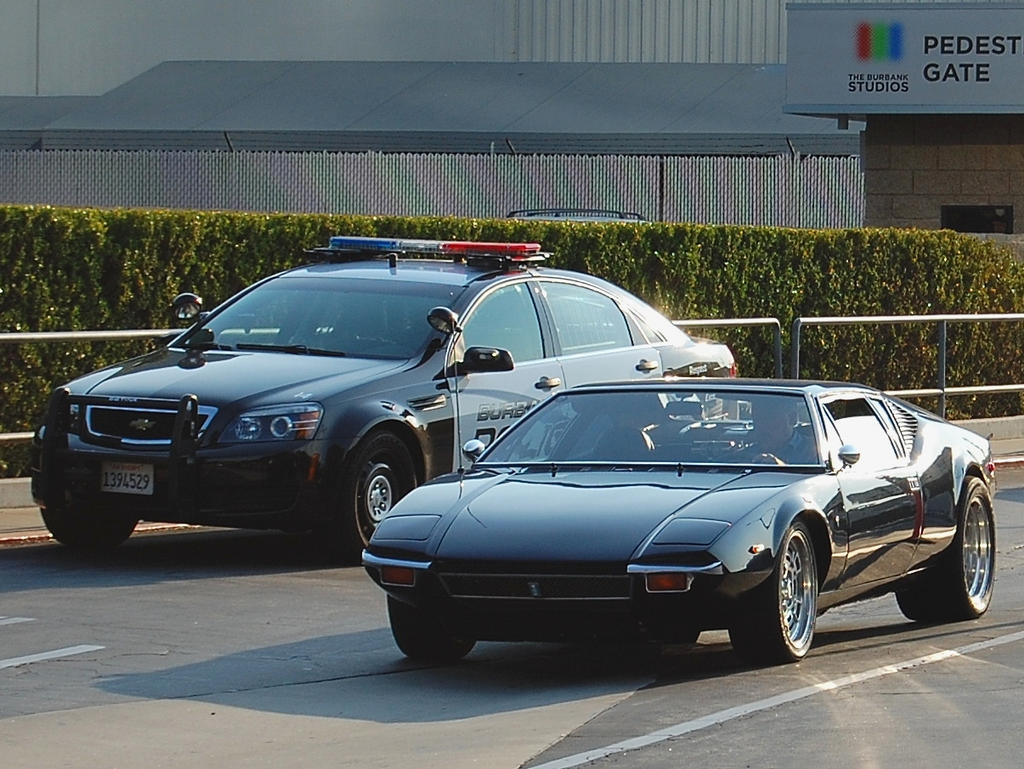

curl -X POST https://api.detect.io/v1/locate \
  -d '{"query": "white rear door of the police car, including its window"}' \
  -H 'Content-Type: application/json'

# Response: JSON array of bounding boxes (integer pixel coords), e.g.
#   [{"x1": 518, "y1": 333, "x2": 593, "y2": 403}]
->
[{"x1": 540, "y1": 280, "x2": 662, "y2": 387}]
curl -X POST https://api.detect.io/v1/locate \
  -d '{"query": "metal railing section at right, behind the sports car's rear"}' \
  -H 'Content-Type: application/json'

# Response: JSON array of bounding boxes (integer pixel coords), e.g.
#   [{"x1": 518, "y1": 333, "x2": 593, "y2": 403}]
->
[{"x1": 791, "y1": 312, "x2": 1024, "y2": 417}]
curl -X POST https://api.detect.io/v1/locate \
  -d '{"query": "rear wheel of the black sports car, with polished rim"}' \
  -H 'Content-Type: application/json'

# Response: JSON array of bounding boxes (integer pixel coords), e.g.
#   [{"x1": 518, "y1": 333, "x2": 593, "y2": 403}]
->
[{"x1": 896, "y1": 477, "x2": 995, "y2": 623}]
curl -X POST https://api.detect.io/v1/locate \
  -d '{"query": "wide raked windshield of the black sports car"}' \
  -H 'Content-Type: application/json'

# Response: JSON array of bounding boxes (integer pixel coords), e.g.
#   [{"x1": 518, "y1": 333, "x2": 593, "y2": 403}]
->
[{"x1": 480, "y1": 388, "x2": 821, "y2": 466}]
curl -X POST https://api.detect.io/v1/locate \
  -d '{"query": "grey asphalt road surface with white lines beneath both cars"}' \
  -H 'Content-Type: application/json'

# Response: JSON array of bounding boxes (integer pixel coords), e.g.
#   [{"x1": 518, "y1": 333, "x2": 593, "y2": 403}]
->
[{"x1": 0, "y1": 469, "x2": 1024, "y2": 769}]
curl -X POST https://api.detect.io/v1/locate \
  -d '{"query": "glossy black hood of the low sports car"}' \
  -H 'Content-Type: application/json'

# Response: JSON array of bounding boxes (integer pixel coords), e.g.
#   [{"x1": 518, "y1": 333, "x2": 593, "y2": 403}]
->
[{"x1": 423, "y1": 470, "x2": 792, "y2": 562}]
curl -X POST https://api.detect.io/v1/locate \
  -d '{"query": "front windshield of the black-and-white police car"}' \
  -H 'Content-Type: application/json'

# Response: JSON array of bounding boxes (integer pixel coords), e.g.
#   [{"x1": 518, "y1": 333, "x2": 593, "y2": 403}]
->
[{"x1": 184, "y1": 277, "x2": 453, "y2": 358}]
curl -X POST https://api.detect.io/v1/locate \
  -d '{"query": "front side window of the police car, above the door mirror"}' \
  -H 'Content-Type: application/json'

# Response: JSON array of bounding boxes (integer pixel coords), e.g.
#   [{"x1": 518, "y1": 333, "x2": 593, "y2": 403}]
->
[{"x1": 462, "y1": 283, "x2": 544, "y2": 364}]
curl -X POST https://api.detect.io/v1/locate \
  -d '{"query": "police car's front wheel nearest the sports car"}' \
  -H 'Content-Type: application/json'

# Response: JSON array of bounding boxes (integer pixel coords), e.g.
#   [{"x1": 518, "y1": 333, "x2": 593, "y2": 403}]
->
[{"x1": 328, "y1": 432, "x2": 416, "y2": 563}]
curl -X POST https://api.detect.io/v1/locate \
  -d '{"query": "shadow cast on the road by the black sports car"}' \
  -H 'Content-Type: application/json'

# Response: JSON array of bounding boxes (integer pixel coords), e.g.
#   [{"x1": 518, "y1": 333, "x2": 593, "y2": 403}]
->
[{"x1": 97, "y1": 606, "x2": 1021, "y2": 724}]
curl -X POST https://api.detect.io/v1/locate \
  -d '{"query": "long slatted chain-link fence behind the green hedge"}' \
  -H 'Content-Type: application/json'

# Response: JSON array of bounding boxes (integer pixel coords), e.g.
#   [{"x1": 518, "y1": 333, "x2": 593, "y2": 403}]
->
[{"x1": 0, "y1": 151, "x2": 864, "y2": 227}]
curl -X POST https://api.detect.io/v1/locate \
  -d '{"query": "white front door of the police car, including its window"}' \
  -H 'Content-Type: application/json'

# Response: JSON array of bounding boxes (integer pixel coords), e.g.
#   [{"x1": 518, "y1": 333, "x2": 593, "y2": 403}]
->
[{"x1": 450, "y1": 281, "x2": 564, "y2": 467}]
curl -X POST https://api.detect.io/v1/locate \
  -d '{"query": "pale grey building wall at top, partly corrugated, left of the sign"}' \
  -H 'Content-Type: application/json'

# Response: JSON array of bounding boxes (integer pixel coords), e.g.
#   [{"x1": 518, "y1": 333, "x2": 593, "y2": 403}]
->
[{"x1": 0, "y1": 0, "x2": 997, "y2": 96}]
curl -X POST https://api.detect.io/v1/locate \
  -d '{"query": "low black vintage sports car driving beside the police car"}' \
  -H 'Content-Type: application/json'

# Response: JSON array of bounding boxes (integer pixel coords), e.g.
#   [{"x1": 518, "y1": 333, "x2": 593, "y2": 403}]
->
[{"x1": 362, "y1": 379, "x2": 995, "y2": 663}]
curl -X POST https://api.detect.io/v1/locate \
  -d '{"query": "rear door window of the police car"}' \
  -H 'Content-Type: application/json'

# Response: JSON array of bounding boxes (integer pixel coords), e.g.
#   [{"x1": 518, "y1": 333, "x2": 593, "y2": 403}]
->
[{"x1": 543, "y1": 282, "x2": 633, "y2": 355}]
